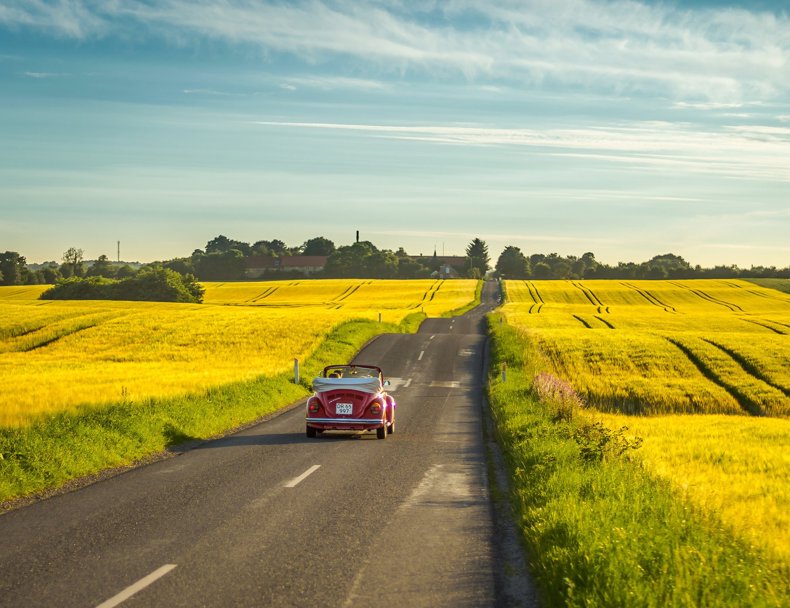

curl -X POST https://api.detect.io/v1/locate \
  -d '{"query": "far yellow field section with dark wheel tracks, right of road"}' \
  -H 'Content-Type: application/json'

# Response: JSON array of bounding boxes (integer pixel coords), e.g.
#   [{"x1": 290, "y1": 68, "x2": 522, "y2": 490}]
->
[{"x1": 504, "y1": 280, "x2": 790, "y2": 416}]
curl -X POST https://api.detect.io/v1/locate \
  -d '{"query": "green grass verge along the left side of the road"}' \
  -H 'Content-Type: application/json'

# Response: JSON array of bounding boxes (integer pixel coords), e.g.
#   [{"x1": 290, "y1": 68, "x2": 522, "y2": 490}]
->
[{"x1": 0, "y1": 313, "x2": 425, "y2": 506}]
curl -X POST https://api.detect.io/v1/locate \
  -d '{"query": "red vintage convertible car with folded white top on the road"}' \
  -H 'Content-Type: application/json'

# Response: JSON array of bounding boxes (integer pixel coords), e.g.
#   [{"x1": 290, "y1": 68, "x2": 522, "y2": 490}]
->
[{"x1": 306, "y1": 364, "x2": 395, "y2": 439}]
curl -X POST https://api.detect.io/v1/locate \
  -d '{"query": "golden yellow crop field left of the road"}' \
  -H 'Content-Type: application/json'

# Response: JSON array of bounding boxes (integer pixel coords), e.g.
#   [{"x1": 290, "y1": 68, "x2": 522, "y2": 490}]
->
[{"x1": 0, "y1": 280, "x2": 476, "y2": 426}]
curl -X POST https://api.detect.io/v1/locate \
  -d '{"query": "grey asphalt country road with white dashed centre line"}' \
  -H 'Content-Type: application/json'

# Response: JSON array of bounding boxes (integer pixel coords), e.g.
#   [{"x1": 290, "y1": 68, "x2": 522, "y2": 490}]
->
[{"x1": 0, "y1": 285, "x2": 540, "y2": 608}]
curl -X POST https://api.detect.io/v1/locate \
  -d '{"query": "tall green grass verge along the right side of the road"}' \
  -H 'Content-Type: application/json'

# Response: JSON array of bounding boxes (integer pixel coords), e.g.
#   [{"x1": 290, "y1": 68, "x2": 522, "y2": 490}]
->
[{"x1": 488, "y1": 314, "x2": 790, "y2": 607}]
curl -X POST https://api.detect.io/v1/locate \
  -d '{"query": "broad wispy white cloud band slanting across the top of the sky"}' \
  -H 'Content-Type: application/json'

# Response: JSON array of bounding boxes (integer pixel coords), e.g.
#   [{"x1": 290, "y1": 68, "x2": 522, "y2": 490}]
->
[{"x1": 0, "y1": 0, "x2": 790, "y2": 103}]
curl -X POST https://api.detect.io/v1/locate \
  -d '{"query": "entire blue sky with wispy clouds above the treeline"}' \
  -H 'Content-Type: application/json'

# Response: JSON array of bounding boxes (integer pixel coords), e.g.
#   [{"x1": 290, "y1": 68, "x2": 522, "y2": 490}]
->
[{"x1": 0, "y1": 0, "x2": 790, "y2": 267}]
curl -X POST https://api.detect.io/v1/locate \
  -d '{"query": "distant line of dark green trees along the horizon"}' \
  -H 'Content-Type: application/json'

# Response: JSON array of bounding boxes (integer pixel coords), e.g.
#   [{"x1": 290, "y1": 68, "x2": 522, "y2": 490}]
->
[{"x1": 0, "y1": 235, "x2": 790, "y2": 291}]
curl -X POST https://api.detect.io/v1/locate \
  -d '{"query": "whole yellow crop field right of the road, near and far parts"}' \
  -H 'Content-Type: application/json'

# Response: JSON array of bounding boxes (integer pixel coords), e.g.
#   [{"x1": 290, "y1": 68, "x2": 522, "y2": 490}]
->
[{"x1": 504, "y1": 280, "x2": 790, "y2": 566}]
